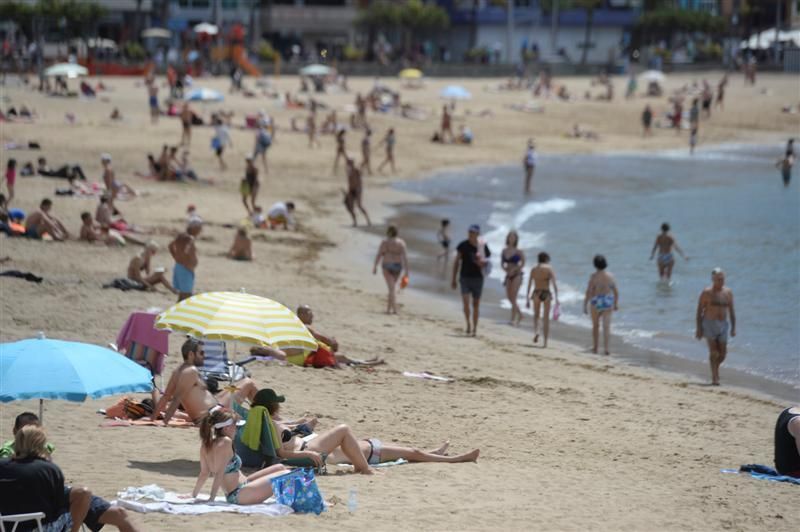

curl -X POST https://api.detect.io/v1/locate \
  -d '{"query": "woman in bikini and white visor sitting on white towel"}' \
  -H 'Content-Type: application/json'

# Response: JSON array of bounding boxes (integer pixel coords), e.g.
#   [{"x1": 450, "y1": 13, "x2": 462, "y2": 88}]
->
[{"x1": 192, "y1": 407, "x2": 288, "y2": 505}]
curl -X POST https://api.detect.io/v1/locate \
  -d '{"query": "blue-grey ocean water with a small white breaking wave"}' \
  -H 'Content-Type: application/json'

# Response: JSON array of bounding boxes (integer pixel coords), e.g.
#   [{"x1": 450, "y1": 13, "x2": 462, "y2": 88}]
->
[{"x1": 398, "y1": 144, "x2": 800, "y2": 389}]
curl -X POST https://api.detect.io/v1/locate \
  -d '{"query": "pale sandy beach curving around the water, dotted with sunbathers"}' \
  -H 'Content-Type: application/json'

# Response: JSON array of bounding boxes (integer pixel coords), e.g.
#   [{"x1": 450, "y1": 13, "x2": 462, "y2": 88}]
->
[{"x1": 0, "y1": 72, "x2": 800, "y2": 530}]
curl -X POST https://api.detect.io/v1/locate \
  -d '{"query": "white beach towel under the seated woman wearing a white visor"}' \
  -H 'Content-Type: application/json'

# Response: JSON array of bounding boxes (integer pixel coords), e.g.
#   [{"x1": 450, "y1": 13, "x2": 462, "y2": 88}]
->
[{"x1": 114, "y1": 484, "x2": 294, "y2": 516}]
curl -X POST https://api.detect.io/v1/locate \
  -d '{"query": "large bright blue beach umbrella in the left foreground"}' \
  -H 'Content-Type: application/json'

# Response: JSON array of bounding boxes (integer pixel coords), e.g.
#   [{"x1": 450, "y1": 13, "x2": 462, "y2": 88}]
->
[{"x1": 0, "y1": 334, "x2": 153, "y2": 418}]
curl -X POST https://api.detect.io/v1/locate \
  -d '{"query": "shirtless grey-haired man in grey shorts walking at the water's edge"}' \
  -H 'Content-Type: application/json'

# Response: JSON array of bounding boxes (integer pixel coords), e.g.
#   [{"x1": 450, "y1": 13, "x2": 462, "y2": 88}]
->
[{"x1": 695, "y1": 268, "x2": 736, "y2": 386}]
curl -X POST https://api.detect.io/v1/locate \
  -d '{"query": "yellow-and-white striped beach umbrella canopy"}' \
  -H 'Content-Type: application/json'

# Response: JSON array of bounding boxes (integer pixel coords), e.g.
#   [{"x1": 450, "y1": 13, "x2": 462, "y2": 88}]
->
[{"x1": 156, "y1": 292, "x2": 317, "y2": 351}]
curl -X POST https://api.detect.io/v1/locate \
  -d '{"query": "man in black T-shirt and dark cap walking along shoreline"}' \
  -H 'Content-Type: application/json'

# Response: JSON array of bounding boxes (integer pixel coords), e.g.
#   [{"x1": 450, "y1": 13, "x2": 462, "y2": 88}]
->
[{"x1": 451, "y1": 224, "x2": 492, "y2": 336}]
